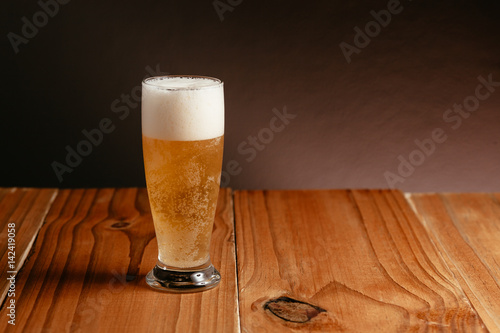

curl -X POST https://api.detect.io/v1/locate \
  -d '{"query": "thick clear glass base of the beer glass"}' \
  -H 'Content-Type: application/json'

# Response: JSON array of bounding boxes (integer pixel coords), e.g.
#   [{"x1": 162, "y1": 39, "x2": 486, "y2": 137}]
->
[{"x1": 146, "y1": 264, "x2": 220, "y2": 293}]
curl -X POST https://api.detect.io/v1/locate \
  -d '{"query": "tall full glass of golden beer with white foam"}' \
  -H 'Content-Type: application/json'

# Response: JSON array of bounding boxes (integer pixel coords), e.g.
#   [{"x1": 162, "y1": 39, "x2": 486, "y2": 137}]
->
[{"x1": 142, "y1": 76, "x2": 224, "y2": 292}]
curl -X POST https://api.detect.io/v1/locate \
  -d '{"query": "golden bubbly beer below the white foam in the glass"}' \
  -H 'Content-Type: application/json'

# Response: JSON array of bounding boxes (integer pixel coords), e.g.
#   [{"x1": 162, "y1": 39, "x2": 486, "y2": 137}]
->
[{"x1": 142, "y1": 136, "x2": 224, "y2": 268}]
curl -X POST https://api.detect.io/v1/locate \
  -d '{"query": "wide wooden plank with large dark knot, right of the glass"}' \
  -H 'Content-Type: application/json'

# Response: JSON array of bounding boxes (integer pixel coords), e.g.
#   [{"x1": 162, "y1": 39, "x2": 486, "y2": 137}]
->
[{"x1": 234, "y1": 190, "x2": 486, "y2": 332}]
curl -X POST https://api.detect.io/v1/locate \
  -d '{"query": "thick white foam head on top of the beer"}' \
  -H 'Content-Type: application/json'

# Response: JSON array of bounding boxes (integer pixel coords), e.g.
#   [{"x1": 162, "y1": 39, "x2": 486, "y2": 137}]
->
[{"x1": 142, "y1": 76, "x2": 224, "y2": 141}]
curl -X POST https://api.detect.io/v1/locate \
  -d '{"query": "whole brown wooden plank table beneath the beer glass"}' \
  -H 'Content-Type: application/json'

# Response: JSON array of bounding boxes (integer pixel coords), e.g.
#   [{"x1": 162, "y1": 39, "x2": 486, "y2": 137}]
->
[{"x1": 0, "y1": 188, "x2": 500, "y2": 332}]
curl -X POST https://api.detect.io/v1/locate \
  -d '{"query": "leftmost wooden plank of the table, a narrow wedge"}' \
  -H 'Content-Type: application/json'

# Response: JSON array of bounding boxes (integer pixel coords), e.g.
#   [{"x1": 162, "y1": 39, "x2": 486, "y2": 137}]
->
[{"x1": 0, "y1": 188, "x2": 57, "y2": 304}]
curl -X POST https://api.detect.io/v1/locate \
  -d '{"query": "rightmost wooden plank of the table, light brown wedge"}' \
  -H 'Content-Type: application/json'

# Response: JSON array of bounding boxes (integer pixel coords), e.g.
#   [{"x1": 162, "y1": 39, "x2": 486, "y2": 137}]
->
[{"x1": 408, "y1": 193, "x2": 500, "y2": 332}]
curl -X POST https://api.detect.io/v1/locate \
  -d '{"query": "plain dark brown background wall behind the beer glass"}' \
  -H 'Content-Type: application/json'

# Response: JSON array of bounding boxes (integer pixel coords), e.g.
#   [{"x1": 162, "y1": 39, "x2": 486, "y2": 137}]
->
[{"x1": 0, "y1": 0, "x2": 500, "y2": 191}]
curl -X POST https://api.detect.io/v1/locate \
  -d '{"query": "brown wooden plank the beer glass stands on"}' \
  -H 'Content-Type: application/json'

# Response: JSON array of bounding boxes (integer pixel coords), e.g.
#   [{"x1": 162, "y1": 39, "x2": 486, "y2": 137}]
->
[{"x1": 0, "y1": 189, "x2": 239, "y2": 332}]
